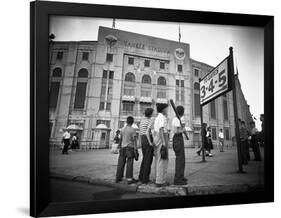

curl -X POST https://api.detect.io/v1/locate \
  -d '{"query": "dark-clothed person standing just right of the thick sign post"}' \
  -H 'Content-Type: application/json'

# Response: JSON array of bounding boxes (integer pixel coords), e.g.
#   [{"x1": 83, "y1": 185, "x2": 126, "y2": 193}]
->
[{"x1": 239, "y1": 120, "x2": 249, "y2": 165}]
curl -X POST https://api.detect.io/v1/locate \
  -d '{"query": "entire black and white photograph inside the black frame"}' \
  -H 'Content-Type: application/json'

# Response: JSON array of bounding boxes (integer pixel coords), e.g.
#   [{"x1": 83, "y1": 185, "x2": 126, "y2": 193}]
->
[{"x1": 48, "y1": 15, "x2": 268, "y2": 202}]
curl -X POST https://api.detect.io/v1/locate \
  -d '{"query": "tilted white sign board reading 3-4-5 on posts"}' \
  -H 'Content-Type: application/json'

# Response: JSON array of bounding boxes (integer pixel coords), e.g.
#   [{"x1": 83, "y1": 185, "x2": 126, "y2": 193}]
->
[{"x1": 200, "y1": 57, "x2": 230, "y2": 105}]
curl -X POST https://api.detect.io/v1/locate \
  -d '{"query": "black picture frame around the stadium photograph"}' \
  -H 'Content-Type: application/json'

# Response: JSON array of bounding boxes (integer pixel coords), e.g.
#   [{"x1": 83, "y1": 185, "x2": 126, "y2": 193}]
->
[{"x1": 30, "y1": 1, "x2": 274, "y2": 217}]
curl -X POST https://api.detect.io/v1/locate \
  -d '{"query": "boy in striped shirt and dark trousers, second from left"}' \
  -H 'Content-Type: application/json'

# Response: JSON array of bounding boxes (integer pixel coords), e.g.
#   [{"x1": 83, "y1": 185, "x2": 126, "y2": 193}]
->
[{"x1": 139, "y1": 108, "x2": 153, "y2": 184}]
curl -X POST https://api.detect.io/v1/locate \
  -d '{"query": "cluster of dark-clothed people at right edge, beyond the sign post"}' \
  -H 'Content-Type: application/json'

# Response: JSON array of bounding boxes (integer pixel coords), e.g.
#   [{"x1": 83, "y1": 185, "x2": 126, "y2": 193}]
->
[{"x1": 238, "y1": 114, "x2": 264, "y2": 165}]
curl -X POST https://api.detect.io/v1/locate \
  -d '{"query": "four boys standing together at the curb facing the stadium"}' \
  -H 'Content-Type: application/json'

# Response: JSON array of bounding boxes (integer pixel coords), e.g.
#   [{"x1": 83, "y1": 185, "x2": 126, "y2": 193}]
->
[{"x1": 116, "y1": 104, "x2": 187, "y2": 187}]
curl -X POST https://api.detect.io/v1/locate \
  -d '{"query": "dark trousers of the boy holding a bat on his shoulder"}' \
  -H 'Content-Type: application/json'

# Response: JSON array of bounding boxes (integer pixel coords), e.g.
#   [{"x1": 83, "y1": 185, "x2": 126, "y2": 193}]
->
[{"x1": 173, "y1": 133, "x2": 185, "y2": 183}]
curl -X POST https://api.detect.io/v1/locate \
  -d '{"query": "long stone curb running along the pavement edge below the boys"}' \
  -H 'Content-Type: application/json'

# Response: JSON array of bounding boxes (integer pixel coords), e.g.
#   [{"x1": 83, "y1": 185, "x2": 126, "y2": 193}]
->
[{"x1": 50, "y1": 173, "x2": 263, "y2": 196}]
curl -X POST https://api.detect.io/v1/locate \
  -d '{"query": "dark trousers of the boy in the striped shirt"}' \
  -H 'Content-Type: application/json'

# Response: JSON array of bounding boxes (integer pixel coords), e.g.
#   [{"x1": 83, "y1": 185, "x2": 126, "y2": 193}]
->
[{"x1": 139, "y1": 135, "x2": 153, "y2": 183}]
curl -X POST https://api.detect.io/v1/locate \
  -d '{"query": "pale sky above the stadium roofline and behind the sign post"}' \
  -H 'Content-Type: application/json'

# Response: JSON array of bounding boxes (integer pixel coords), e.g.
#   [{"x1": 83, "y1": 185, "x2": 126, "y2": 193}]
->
[{"x1": 50, "y1": 16, "x2": 264, "y2": 129}]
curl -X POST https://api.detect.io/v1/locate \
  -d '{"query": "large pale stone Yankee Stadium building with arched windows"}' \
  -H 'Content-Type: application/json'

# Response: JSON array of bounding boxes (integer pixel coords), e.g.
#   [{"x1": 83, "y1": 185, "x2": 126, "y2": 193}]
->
[{"x1": 49, "y1": 27, "x2": 252, "y2": 149}]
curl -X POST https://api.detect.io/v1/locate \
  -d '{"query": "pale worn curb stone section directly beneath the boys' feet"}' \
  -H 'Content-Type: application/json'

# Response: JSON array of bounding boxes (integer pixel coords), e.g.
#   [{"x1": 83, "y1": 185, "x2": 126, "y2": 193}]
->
[{"x1": 137, "y1": 184, "x2": 188, "y2": 196}]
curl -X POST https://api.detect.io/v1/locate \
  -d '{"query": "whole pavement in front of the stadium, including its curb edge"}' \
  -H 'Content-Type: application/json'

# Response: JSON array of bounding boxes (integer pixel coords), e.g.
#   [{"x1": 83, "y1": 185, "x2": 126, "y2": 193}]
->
[{"x1": 50, "y1": 147, "x2": 264, "y2": 195}]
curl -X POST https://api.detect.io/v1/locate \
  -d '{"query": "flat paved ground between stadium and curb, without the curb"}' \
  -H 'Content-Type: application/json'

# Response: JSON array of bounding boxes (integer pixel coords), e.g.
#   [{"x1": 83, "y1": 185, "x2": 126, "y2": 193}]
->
[{"x1": 50, "y1": 147, "x2": 264, "y2": 189}]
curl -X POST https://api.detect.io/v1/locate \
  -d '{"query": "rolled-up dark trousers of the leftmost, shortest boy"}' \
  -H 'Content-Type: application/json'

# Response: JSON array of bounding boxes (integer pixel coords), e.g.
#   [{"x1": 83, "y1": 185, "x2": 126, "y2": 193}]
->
[{"x1": 116, "y1": 147, "x2": 134, "y2": 181}]
